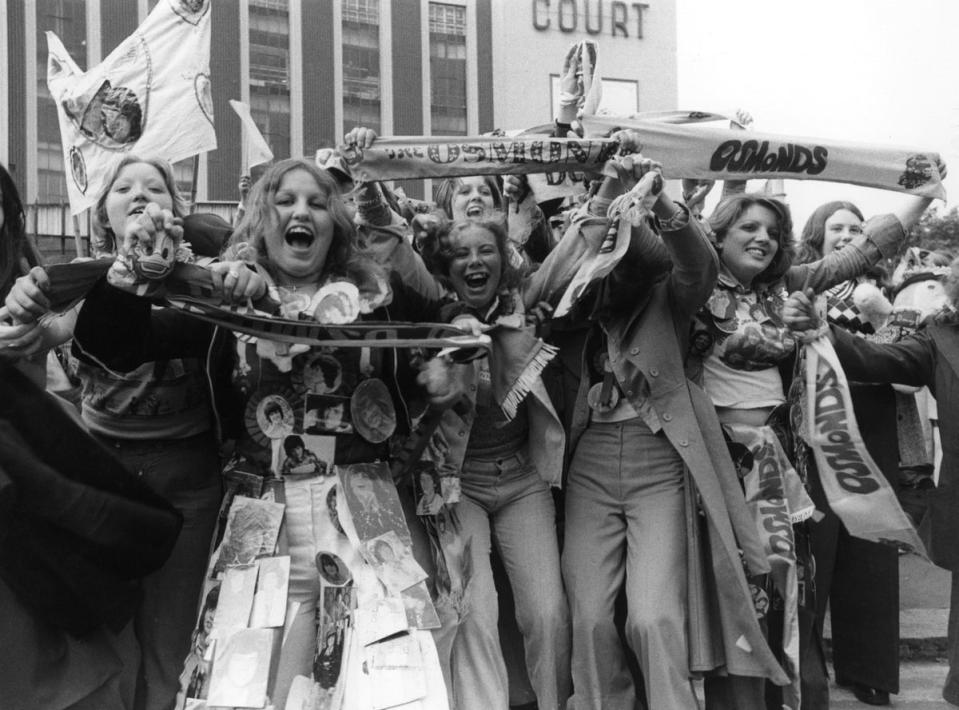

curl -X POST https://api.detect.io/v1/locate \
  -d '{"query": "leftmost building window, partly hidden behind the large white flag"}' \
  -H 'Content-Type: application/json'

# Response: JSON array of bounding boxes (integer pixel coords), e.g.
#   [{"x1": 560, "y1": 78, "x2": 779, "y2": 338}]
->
[{"x1": 36, "y1": 0, "x2": 87, "y2": 202}]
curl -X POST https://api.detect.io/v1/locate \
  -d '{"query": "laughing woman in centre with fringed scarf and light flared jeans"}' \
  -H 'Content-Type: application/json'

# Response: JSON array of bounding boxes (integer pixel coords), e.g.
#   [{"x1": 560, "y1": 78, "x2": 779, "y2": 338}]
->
[{"x1": 422, "y1": 217, "x2": 570, "y2": 710}]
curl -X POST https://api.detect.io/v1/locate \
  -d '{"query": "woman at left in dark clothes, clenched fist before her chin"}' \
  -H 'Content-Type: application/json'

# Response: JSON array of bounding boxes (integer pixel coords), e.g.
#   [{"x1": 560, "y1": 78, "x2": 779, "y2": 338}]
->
[{"x1": 7, "y1": 155, "x2": 244, "y2": 707}]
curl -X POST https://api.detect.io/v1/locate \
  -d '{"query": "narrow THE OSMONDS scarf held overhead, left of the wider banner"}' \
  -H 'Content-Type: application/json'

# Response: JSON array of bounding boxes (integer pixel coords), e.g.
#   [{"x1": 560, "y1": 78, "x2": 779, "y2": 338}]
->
[{"x1": 341, "y1": 136, "x2": 619, "y2": 182}]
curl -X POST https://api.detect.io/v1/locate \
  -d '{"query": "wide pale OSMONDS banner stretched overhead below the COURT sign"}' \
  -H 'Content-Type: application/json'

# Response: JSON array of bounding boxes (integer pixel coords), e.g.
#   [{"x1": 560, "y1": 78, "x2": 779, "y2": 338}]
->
[{"x1": 583, "y1": 116, "x2": 946, "y2": 200}]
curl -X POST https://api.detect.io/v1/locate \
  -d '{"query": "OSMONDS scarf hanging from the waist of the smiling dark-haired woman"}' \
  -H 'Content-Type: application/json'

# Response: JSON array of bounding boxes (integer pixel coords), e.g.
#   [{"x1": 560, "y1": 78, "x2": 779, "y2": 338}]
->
[{"x1": 726, "y1": 424, "x2": 812, "y2": 710}]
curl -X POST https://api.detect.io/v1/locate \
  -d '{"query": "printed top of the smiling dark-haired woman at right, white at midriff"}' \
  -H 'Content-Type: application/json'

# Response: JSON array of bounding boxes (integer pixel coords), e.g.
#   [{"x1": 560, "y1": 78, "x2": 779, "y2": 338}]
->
[{"x1": 689, "y1": 269, "x2": 796, "y2": 409}]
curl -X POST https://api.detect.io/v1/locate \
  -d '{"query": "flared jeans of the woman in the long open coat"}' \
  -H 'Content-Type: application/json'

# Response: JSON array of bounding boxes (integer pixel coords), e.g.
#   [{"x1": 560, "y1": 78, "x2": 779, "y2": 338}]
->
[{"x1": 563, "y1": 418, "x2": 699, "y2": 710}]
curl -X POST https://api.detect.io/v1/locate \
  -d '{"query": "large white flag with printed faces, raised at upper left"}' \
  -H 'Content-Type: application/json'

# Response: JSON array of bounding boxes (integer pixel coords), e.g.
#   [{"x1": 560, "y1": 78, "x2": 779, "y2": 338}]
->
[{"x1": 47, "y1": 0, "x2": 216, "y2": 214}]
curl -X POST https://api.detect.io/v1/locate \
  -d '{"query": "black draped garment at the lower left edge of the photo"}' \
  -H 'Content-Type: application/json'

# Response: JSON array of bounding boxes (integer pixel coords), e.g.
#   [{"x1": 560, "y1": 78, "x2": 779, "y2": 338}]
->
[{"x1": 0, "y1": 361, "x2": 182, "y2": 635}]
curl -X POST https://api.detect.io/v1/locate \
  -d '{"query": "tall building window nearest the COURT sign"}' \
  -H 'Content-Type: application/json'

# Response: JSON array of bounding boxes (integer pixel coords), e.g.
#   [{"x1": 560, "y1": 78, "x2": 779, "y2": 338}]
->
[{"x1": 430, "y1": 2, "x2": 467, "y2": 136}]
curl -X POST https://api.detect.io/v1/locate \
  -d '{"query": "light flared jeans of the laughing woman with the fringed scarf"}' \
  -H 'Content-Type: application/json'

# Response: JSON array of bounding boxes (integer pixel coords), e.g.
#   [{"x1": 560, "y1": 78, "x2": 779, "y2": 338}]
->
[{"x1": 451, "y1": 454, "x2": 570, "y2": 710}]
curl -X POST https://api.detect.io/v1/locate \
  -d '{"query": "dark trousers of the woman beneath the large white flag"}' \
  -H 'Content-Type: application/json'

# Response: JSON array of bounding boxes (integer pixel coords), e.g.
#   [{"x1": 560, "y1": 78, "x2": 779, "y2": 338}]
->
[{"x1": 97, "y1": 434, "x2": 222, "y2": 710}]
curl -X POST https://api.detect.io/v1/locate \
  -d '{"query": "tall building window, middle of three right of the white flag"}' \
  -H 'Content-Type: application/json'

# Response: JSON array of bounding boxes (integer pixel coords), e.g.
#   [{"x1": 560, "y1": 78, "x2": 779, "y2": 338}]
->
[{"x1": 343, "y1": 0, "x2": 381, "y2": 133}]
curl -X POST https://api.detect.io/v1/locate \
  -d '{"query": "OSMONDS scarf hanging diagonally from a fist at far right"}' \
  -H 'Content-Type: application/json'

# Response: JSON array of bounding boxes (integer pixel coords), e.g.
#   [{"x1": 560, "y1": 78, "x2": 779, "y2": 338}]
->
[{"x1": 805, "y1": 338, "x2": 927, "y2": 557}]
